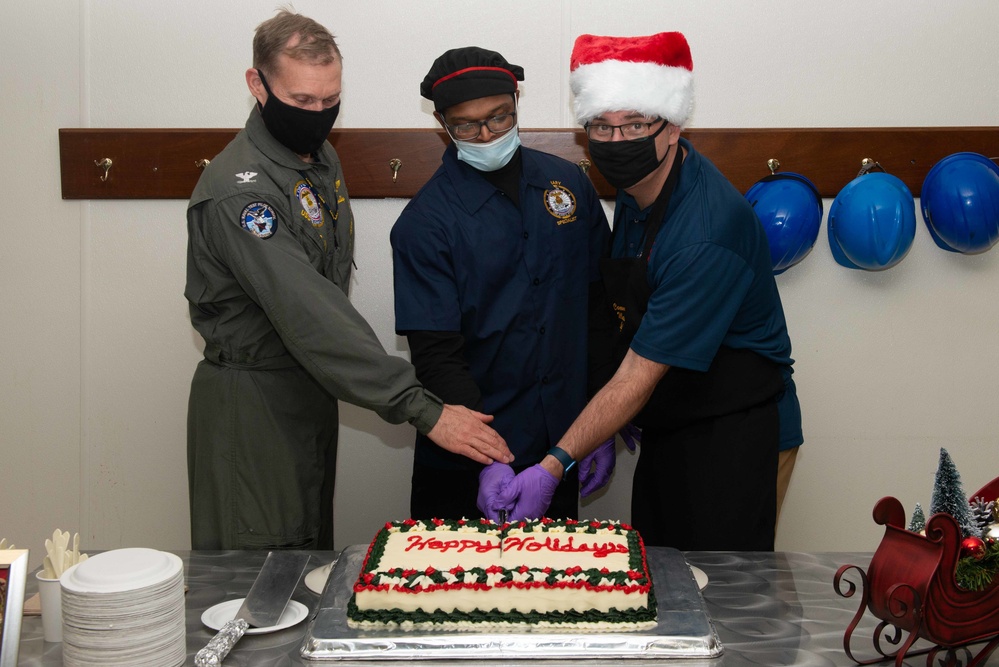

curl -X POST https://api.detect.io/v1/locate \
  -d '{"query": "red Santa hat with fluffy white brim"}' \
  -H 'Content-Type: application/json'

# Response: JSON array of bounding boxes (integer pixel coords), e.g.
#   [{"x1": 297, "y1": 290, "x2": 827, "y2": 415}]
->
[{"x1": 569, "y1": 32, "x2": 694, "y2": 127}]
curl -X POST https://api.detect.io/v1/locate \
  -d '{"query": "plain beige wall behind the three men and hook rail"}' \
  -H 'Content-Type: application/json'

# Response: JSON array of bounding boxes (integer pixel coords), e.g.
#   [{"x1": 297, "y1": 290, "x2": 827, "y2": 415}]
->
[{"x1": 0, "y1": 0, "x2": 999, "y2": 564}]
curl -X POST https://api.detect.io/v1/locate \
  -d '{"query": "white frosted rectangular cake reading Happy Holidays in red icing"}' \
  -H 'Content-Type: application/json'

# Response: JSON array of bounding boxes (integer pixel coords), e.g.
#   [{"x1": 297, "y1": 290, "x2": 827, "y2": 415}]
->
[{"x1": 347, "y1": 519, "x2": 656, "y2": 632}]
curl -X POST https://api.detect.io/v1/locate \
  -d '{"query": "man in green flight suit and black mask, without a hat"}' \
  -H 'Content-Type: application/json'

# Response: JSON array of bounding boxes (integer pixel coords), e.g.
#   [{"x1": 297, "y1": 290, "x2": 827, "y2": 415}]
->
[{"x1": 184, "y1": 10, "x2": 513, "y2": 549}]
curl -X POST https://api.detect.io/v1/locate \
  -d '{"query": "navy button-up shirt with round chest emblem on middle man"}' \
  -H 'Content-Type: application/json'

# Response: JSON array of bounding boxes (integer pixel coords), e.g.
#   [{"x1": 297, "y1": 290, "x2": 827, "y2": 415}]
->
[{"x1": 391, "y1": 146, "x2": 609, "y2": 467}]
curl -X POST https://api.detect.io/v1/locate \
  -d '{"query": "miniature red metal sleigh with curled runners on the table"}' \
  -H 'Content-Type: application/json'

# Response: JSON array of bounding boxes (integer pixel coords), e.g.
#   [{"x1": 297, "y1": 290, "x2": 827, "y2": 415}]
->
[{"x1": 833, "y1": 477, "x2": 999, "y2": 667}]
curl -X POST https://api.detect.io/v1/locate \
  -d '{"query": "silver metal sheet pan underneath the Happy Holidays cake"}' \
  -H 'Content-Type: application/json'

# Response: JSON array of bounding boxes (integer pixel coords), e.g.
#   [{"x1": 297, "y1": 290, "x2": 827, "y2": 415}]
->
[{"x1": 302, "y1": 545, "x2": 723, "y2": 662}]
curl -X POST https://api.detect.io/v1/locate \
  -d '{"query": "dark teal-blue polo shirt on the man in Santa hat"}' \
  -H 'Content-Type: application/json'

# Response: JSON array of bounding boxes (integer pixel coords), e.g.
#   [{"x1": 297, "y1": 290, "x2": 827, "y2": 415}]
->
[{"x1": 611, "y1": 139, "x2": 802, "y2": 449}]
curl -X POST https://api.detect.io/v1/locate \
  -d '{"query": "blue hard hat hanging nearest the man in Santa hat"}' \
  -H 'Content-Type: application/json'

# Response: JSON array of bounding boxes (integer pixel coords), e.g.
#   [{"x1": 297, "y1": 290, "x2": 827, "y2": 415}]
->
[{"x1": 746, "y1": 172, "x2": 822, "y2": 275}]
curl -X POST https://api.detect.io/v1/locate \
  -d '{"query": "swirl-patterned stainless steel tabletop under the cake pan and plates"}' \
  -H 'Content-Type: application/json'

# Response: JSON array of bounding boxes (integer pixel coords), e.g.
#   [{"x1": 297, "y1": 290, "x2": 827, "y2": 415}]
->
[{"x1": 11, "y1": 551, "x2": 999, "y2": 667}]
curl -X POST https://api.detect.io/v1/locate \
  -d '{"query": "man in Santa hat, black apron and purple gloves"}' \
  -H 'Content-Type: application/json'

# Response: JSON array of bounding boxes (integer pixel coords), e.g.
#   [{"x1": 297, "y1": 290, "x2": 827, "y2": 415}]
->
[{"x1": 488, "y1": 32, "x2": 802, "y2": 551}]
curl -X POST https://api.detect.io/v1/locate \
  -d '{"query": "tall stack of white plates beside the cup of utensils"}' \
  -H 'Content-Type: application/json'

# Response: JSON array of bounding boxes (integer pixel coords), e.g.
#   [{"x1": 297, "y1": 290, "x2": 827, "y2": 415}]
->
[{"x1": 59, "y1": 549, "x2": 187, "y2": 667}]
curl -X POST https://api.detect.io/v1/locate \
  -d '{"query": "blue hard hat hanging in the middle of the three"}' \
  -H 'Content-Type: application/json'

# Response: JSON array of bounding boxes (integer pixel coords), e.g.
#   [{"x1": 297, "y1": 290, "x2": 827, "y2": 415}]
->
[{"x1": 828, "y1": 172, "x2": 916, "y2": 271}]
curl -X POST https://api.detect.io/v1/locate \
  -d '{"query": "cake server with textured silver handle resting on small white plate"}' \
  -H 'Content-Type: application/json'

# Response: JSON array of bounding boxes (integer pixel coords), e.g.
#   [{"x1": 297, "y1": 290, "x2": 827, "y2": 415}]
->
[{"x1": 194, "y1": 551, "x2": 309, "y2": 667}]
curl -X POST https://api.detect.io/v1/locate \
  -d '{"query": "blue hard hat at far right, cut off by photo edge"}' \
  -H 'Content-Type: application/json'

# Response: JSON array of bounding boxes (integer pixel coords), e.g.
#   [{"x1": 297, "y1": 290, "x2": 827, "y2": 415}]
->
[{"x1": 920, "y1": 153, "x2": 999, "y2": 254}]
